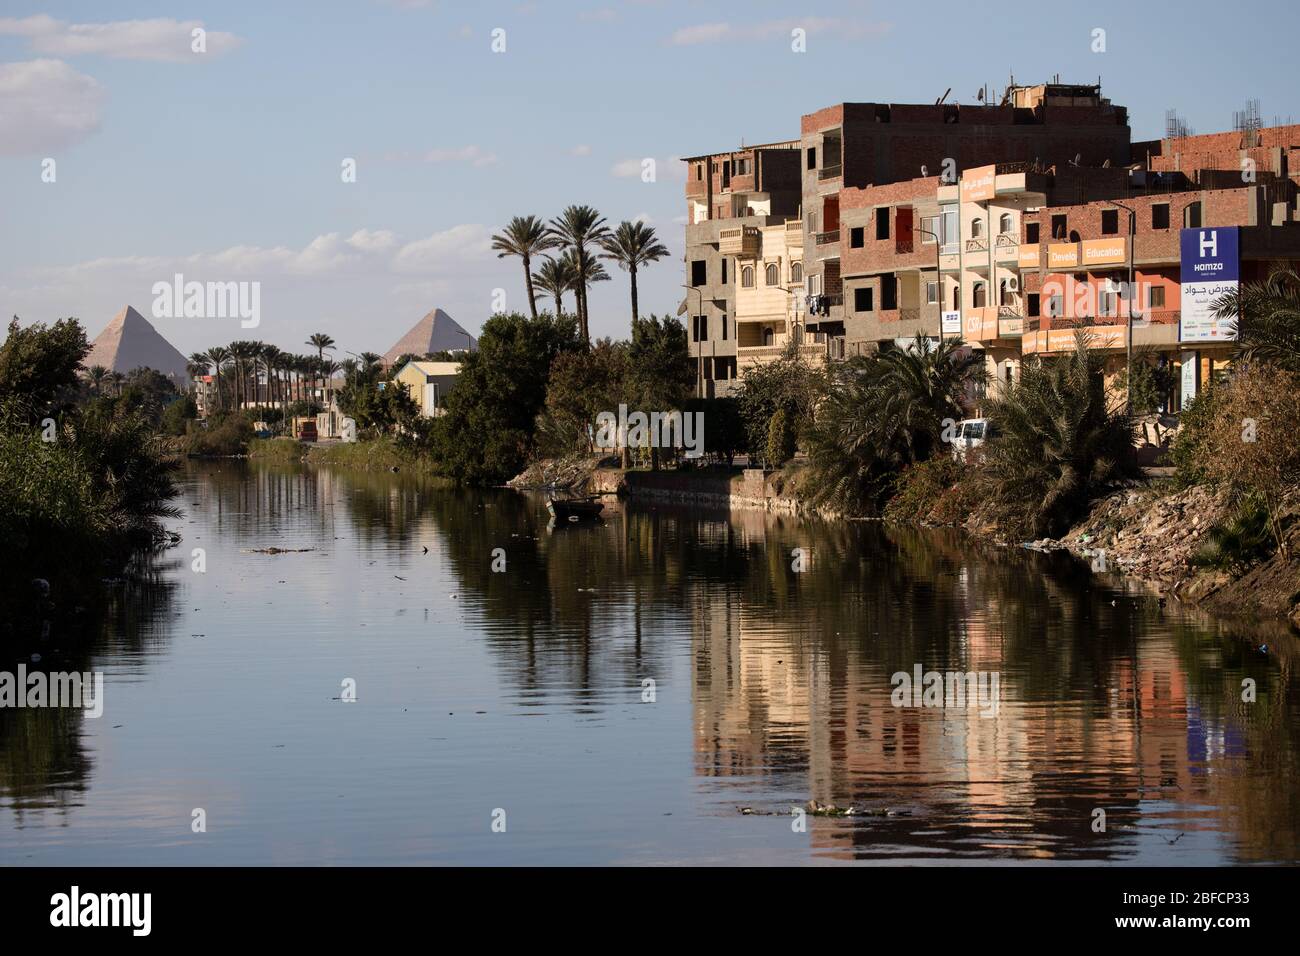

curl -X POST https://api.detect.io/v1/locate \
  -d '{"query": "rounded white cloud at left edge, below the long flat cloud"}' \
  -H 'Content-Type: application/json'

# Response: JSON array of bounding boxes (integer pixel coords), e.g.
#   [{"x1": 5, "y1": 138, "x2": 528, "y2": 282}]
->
[{"x1": 0, "y1": 60, "x2": 105, "y2": 156}]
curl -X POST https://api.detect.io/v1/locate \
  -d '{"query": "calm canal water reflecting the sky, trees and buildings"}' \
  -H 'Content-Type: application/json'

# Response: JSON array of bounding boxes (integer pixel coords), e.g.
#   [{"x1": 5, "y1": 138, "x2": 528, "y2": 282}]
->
[{"x1": 0, "y1": 462, "x2": 1300, "y2": 865}]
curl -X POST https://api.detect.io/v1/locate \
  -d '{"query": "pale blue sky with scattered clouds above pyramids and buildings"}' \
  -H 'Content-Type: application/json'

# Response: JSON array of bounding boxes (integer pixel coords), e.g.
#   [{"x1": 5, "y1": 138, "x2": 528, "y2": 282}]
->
[{"x1": 0, "y1": 0, "x2": 1300, "y2": 352}]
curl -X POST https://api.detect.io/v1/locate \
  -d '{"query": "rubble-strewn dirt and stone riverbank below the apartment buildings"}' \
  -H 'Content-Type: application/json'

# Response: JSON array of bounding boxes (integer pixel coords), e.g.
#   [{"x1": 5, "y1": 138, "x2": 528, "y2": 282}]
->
[{"x1": 507, "y1": 459, "x2": 1300, "y2": 628}]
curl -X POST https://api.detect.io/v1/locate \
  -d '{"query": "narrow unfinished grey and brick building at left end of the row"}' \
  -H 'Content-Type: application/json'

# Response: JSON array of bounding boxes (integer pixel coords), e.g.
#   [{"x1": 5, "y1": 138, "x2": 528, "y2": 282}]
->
[{"x1": 677, "y1": 140, "x2": 800, "y2": 395}]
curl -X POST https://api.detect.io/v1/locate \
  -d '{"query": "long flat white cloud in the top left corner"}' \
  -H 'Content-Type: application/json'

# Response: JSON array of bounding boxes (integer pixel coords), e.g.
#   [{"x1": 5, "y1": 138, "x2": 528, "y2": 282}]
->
[{"x1": 0, "y1": 14, "x2": 243, "y2": 62}]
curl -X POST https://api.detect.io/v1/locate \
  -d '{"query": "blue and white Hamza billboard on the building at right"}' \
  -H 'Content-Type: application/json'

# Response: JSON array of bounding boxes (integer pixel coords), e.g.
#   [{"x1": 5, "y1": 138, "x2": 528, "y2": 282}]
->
[{"x1": 1178, "y1": 226, "x2": 1242, "y2": 342}]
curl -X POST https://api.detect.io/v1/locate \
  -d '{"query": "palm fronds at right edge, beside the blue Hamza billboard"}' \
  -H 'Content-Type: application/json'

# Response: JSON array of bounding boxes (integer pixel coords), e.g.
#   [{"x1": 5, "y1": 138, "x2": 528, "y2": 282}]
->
[{"x1": 1214, "y1": 269, "x2": 1300, "y2": 375}]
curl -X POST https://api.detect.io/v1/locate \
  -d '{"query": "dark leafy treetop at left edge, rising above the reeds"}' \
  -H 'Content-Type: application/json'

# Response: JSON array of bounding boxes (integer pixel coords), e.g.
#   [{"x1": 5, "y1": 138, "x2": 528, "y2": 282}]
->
[{"x1": 0, "y1": 316, "x2": 90, "y2": 419}]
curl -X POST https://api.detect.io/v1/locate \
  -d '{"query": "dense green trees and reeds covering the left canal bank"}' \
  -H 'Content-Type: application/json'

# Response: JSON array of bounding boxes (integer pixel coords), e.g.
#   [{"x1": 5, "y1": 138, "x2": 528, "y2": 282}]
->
[{"x1": 0, "y1": 319, "x2": 182, "y2": 636}]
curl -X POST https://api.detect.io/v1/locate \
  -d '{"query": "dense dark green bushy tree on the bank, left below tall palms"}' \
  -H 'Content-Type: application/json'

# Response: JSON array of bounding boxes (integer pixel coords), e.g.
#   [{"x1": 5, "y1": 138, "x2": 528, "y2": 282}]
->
[{"x1": 430, "y1": 312, "x2": 584, "y2": 484}]
